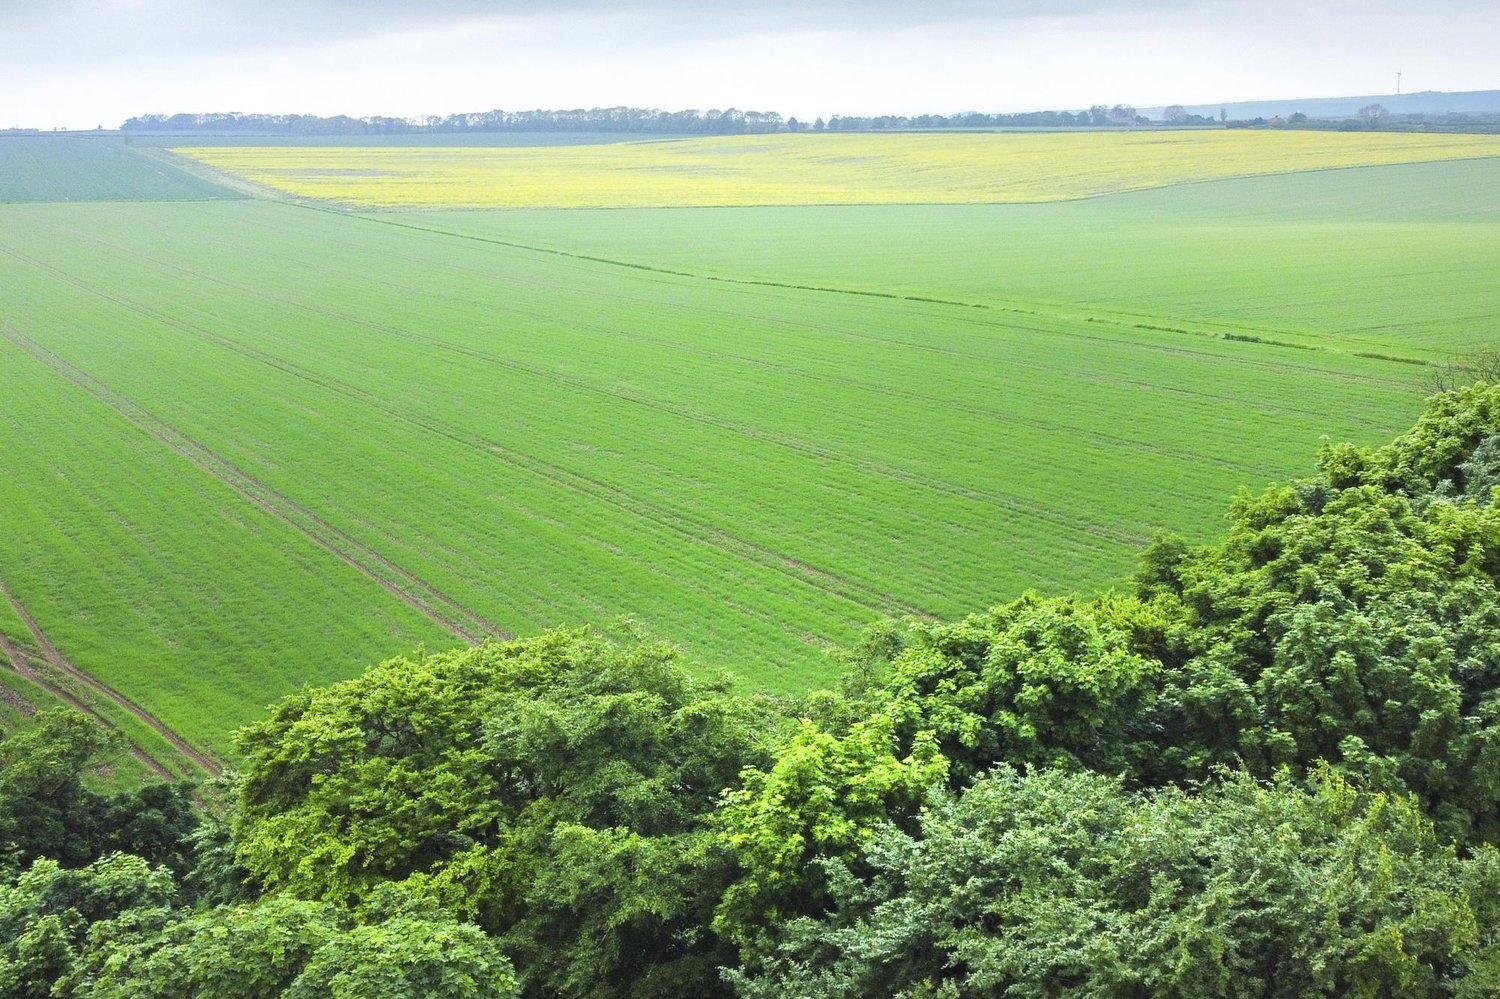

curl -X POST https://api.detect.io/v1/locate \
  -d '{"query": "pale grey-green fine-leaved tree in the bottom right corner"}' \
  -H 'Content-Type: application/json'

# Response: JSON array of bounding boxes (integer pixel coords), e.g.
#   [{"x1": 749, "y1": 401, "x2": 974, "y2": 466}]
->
[{"x1": 732, "y1": 770, "x2": 1497, "y2": 999}]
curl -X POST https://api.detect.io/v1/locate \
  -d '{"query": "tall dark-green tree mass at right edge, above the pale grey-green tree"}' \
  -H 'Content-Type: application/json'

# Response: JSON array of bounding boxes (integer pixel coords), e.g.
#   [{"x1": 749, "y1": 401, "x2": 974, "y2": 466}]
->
[{"x1": 1140, "y1": 389, "x2": 1500, "y2": 843}]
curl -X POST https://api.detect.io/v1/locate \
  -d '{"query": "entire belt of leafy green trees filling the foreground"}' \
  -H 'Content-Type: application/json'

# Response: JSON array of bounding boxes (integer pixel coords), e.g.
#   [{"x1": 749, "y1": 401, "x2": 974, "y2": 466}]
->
[{"x1": 0, "y1": 384, "x2": 1500, "y2": 999}]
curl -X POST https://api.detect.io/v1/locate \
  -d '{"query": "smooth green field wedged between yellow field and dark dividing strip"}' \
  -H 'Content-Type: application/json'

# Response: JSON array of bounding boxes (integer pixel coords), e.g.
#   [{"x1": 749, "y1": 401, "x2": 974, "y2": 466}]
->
[{"x1": 414, "y1": 159, "x2": 1500, "y2": 355}]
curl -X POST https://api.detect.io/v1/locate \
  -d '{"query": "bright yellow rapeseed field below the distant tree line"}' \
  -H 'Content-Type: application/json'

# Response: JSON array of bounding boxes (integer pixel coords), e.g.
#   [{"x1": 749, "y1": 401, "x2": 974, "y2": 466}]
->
[{"x1": 176, "y1": 131, "x2": 1500, "y2": 209}]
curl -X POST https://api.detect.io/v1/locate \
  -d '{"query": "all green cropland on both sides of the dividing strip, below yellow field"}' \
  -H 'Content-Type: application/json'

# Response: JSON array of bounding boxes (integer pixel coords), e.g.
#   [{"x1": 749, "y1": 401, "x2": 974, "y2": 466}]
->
[{"x1": 0, "y1": 141, "x2": 1500, "y2": 758}]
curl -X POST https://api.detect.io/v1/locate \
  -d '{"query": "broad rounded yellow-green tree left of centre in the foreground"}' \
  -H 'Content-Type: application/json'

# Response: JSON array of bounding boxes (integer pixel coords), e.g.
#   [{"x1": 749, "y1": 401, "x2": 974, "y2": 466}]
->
[{"x1": 233, "y1": 632, "x2": 774, "y2": 996}]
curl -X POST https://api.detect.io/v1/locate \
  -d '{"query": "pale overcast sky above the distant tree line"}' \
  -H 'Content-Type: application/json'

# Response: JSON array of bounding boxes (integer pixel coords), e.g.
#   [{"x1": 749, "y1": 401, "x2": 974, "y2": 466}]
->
[{"x1": 0, "y1": 0, "x2": 1500, "y2": 129}]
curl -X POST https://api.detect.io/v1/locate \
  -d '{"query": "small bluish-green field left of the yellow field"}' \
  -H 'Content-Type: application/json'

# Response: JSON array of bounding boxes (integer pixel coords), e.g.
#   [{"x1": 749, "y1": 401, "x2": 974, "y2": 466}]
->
[{"x1": 0, "y1": 135, "x2": 242, "y2": 203}]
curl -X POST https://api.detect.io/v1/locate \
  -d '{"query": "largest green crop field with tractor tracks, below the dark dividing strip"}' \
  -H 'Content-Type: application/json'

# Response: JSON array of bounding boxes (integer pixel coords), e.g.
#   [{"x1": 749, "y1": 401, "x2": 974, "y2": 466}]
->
[{"x1": 0, "y1": 203, "x2": 1419, "y2": 746}]
